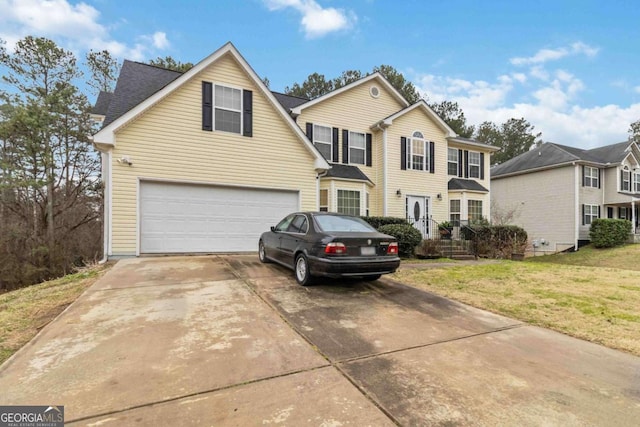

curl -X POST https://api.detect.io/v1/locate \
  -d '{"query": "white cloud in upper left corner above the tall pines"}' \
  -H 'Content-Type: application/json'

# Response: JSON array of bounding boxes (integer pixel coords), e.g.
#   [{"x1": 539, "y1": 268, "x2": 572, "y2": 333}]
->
[{"x1": 0, "y1": 0, "x2": 169, "y2": 60}]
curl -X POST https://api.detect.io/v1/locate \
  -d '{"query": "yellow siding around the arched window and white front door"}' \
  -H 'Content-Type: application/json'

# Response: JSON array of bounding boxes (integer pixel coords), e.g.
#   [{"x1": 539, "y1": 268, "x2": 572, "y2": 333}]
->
[{"x1": 387, "y1": 108, "x2": 449, "y2": 222}]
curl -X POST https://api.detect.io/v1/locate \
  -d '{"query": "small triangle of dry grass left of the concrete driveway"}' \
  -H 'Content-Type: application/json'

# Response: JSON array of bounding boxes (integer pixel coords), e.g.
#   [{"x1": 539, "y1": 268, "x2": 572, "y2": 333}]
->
[{"x1": 0, "y1": 265, "x2": 109, "y2": 364}]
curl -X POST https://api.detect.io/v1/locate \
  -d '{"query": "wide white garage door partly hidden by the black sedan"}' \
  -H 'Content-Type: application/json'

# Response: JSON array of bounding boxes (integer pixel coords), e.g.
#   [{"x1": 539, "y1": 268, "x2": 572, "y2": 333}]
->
[{"x1": 140, "y1": 182, "x2": 299, "y2": 253}]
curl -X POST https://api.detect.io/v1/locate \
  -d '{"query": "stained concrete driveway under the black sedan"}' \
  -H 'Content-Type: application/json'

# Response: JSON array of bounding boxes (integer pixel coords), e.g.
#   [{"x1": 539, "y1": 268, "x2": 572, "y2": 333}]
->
[{"x1": 0, "y1": 255, "x2": 640, "y2": 426}]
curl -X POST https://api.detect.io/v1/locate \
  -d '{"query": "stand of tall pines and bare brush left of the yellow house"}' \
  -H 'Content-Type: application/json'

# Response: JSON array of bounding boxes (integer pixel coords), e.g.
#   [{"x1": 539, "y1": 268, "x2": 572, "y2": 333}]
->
[{"x1": 0, "y1": 36, "x2": 101, "y2": 288}]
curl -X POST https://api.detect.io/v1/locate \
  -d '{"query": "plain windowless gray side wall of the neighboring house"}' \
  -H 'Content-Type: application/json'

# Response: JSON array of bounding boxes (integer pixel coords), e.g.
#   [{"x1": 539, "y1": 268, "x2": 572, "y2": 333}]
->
[{"x1": 491, "y1": 165, "x2": 581, "y2": 251}]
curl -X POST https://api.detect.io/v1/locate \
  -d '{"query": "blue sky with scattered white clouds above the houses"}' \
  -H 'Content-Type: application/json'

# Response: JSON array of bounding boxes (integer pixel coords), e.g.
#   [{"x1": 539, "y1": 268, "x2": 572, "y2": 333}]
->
[{"x1": 0, "y1": 0, "x2": 640, "y2": 148}]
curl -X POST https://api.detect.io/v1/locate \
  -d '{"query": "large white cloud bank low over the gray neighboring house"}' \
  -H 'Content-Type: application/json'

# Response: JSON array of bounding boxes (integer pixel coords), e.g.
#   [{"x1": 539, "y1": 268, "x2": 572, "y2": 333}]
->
[{"x1": 414, "y1": 49, "x2": 640, "y2": 148}]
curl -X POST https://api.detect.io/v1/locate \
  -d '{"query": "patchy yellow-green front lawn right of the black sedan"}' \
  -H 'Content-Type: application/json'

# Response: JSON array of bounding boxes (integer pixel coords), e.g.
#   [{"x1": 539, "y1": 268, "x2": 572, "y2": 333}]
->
[{"x1": 391, "y1": 245, "x2": 640, "y2": 356}]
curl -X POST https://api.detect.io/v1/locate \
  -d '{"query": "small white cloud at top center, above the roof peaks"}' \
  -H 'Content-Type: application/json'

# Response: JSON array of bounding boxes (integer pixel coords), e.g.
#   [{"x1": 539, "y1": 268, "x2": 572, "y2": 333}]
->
[{"x1": 264, "y1": 0, "x2": 358, "y2": 38}]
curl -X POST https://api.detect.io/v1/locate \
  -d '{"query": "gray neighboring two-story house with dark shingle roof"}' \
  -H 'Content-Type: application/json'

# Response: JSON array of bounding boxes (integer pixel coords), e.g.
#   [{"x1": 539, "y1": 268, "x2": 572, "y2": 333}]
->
[{"x1": 491, "y1": 141, "x2": 640, "y2": 252}]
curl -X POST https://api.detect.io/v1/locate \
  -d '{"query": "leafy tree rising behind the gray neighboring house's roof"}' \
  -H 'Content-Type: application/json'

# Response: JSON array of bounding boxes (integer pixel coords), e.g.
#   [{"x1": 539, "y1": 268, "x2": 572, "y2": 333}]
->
[{"x1": 475, "y1": 118, "x2": 542, "y2": 164}]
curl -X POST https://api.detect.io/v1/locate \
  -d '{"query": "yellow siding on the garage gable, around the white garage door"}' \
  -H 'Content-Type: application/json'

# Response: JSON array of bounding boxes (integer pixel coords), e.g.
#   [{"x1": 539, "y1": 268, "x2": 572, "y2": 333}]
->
[{"x1": 112, "y1": 55, "x2": 317, "y2": 255}]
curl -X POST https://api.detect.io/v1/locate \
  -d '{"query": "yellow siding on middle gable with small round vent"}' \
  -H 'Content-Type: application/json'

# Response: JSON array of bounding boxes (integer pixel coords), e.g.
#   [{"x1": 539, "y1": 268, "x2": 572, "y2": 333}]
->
[{"x1": 296, "y1": 80, "x2": 404, "y2": 215}]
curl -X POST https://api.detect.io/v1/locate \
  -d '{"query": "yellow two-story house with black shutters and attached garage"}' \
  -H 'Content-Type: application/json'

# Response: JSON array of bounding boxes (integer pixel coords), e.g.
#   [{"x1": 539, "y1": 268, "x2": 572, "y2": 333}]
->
[{"x1": 94, "y1": 43, "x2": 496, "y2": 257}]
